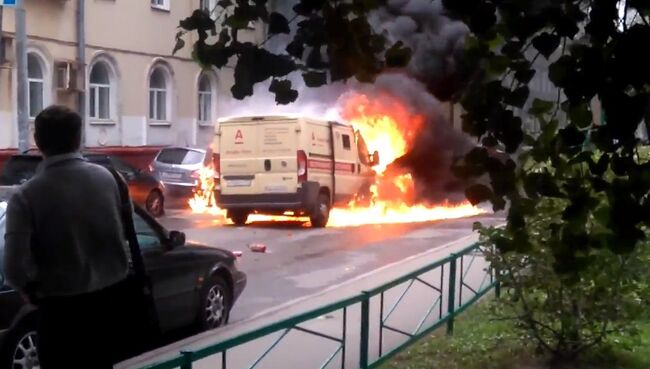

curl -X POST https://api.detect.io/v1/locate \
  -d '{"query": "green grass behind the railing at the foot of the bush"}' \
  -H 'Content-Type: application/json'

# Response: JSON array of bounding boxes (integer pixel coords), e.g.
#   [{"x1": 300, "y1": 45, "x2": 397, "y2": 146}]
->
[{"x1": 381, "y1": 302, "x2": 650, "y2": 369}]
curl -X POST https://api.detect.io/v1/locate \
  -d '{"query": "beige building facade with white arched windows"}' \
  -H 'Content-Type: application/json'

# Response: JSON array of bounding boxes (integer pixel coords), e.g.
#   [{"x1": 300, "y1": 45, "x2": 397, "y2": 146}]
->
[{"x1": 0, "y1": 0, "x2": 263, "y2": 158}]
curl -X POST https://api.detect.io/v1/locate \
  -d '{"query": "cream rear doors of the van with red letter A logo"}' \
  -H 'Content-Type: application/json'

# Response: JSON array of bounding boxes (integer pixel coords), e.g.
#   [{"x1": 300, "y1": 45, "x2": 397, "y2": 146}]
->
[{"x1": 220, "y1": 118, "x2": 299, "y2": 195}]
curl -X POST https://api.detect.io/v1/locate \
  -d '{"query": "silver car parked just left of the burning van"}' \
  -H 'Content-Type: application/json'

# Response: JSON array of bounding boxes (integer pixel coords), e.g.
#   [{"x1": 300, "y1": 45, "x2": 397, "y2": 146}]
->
[{"x1": 149, "y1": 147, "x2": 207, "y2": 197}]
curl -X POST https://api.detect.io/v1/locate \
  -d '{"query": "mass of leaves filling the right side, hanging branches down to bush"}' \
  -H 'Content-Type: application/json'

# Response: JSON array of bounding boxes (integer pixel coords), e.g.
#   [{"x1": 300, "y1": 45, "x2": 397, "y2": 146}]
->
[{"x1": 444, "y1": 0, "x2": 650, "y2": 357}]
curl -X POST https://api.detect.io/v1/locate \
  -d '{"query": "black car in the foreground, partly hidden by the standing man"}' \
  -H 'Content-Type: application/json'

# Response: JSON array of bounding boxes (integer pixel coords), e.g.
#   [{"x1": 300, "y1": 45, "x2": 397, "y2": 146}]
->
[{"x1": 0, "y1": 202, "x2": 246, "y2": 369}]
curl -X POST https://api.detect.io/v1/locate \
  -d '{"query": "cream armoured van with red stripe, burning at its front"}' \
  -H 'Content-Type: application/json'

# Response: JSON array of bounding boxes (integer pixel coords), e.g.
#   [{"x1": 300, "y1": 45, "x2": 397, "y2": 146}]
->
[{"x1": 212, "y1": 116, "x2": 379, "y2": 227}]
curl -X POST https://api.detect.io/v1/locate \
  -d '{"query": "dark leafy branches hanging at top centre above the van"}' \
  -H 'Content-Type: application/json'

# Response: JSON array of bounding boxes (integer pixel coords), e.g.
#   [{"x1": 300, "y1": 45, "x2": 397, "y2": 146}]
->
[{"x1": 174, "y1": 0, "x2": 404, "y2": 104}]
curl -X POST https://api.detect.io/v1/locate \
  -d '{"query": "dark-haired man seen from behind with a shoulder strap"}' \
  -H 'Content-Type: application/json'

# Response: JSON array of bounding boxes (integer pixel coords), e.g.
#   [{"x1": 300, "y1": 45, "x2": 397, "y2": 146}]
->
[{"x1": 5, "y1": 106, "x2": 129, "y2": 369}]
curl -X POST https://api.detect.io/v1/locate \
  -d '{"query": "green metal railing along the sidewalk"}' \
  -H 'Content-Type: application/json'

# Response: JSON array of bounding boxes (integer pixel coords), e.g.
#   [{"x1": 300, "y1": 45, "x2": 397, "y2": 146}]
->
[{"x1": 141, "y1": 244, "x2": 499, "y2": 369}]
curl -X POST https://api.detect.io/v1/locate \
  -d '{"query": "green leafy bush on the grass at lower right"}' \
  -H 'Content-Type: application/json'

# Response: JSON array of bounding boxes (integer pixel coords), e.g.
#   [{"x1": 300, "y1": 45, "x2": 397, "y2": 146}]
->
[{"x1": 479, "y1": 204, "x2": 650, "y2": 363}]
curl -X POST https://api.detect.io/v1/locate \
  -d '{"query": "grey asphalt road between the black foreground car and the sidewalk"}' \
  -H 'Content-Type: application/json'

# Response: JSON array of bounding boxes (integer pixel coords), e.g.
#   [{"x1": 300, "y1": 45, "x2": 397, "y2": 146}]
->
[{"x1": 161, "y1": 211, "x2": 503, "y2": 323}]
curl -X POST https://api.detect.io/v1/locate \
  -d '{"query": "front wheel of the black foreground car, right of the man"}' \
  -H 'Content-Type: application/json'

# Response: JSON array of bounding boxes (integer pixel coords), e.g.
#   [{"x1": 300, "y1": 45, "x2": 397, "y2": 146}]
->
[{"x1": 199, "y1": 276, "x2": 232, "y2": 331}]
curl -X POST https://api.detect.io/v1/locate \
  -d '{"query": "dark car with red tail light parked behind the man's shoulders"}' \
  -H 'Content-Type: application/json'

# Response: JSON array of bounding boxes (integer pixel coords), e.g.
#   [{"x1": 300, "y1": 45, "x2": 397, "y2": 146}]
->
[{"x1": 0, "y1": 153, "x2": 165, "y2": 217}]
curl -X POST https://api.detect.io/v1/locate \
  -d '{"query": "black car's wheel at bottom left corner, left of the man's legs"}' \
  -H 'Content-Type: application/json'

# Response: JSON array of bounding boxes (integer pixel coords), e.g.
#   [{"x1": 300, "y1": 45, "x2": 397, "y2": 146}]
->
[{"x1": 0, "y1": 326, "x2": 40, "y2": 369}]
